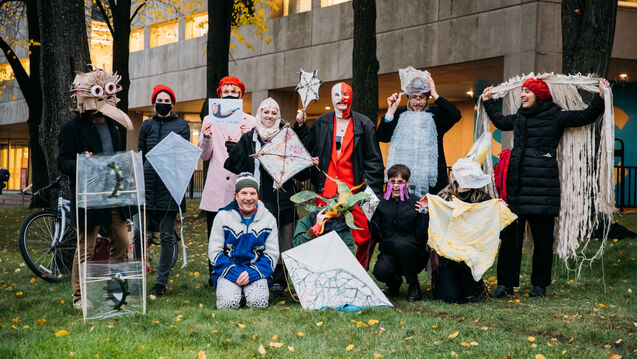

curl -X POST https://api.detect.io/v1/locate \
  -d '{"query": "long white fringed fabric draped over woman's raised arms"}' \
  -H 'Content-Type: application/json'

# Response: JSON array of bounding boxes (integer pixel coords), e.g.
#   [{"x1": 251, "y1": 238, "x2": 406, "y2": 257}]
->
[{"x1": 474, "y1": 73, "x2": 615, "y2": 276}]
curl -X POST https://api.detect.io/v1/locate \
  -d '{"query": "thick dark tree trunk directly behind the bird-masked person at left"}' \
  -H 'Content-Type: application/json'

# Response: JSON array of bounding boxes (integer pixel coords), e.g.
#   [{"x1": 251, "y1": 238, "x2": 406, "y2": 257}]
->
[{"x1": 37, "y1": 0, "x2": 91, "y2": 184}]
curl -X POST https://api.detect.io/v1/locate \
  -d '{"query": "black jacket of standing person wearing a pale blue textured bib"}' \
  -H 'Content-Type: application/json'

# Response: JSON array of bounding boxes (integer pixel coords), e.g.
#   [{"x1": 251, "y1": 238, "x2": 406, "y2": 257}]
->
[{"x1": 376, "y1": 97, "x2": 462, "y2": 194}]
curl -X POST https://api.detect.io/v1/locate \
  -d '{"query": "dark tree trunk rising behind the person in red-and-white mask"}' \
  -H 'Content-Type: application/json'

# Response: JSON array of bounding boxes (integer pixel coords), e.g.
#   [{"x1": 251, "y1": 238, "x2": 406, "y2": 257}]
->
[{"x1": 352, "y1": 0, "x2": 379, "y2": 123}]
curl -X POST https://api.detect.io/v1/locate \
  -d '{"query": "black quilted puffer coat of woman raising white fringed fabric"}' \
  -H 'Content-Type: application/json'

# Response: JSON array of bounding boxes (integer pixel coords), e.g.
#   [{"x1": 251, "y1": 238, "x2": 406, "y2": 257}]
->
[{"x1": 484, "y1": 95, "x2": 604, "y2": 216}]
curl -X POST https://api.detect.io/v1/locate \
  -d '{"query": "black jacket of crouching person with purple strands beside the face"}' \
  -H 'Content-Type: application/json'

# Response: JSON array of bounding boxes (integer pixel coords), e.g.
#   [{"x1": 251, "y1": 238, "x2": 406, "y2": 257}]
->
[{"x1": 370, "y1": 196, "x2": 429, "y2": 253}]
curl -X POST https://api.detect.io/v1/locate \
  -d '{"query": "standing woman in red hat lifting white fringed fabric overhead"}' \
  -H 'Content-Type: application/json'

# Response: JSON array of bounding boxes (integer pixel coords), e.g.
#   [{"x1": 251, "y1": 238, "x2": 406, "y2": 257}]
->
[{"x1": 482, "y1": 78, "x2": 609, "y2": 298}]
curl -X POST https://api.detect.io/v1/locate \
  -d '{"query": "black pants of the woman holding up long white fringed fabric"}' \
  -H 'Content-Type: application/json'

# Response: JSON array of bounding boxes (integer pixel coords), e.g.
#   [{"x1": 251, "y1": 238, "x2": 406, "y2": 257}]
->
[{"x1": 497, "y1": 215, "x2": 555, "y2": 287}]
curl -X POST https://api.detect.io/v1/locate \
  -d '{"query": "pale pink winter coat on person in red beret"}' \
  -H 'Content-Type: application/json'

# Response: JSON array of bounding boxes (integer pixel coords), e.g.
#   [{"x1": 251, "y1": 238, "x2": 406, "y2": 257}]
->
[{"x1": 199, "y1": 113, "x2": 256, "y2": 212}]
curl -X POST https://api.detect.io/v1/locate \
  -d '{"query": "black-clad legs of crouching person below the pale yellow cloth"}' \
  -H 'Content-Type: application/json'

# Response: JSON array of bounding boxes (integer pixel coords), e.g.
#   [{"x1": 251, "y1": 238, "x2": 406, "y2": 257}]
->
[{"x1": 431, "y1": 255, "x2": 484, "y2": 303}]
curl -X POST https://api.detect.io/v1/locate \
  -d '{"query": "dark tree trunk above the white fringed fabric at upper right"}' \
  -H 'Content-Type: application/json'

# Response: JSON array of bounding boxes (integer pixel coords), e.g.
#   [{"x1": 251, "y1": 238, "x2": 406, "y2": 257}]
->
[{"x1": 562, "y1": 0, "x2": 617, "y2": 77}]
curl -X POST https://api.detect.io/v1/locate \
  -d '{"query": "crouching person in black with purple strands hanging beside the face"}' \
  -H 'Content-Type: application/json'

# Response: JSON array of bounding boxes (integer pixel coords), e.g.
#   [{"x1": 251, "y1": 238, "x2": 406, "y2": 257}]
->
[{"x1": 370, "y1": 164, "x2": 429, "y2": 302}]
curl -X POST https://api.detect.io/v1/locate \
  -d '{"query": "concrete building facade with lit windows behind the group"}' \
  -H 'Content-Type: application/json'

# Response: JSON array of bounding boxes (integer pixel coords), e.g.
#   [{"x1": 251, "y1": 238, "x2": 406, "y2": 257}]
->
[{"x1": 0, "y1": 0, "x2": 637, "y2": 193}]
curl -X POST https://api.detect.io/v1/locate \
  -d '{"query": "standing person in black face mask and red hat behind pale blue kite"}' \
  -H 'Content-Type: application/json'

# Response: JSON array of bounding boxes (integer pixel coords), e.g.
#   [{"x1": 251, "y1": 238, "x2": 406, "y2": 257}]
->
[{"x1": 138, "y1": 85, "x2": 190, "y2": 296}]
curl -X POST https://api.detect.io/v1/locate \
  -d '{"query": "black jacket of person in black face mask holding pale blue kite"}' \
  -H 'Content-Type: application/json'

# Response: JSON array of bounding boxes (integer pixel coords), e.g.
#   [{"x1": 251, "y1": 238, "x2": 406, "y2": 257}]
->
[{"x1": 137, "y1": 112, "x2": 190, "y2": 212}]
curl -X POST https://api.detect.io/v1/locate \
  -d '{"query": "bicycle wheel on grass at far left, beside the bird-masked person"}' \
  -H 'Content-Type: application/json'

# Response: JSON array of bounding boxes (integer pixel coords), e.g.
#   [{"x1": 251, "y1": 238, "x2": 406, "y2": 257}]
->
[{"x1": 18, "y1": 210, "x2": 77, "y2": 282}]
